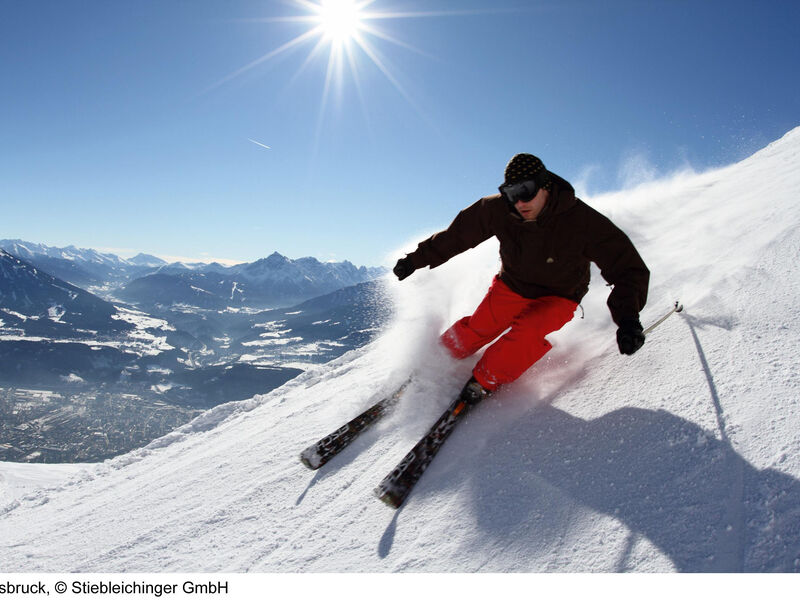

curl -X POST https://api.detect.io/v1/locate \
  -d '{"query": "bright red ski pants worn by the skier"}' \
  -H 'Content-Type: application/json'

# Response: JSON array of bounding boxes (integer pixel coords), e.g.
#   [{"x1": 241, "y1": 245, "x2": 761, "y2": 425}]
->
[{"x1": 441, "y1": 277, "x2": 578, "y2": 390}]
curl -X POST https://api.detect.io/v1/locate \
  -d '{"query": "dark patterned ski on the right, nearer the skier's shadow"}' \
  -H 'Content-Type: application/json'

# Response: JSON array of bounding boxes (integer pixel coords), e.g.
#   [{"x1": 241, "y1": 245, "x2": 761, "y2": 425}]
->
[{"x1": 375, "y1": 396, "x2": 470, "y2": 508}]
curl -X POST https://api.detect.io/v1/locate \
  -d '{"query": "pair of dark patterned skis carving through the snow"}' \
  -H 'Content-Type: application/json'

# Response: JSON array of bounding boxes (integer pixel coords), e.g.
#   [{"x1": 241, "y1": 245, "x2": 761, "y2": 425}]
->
[{"x1": 300, "y1": 378, "x2": 476, "y2": 508}]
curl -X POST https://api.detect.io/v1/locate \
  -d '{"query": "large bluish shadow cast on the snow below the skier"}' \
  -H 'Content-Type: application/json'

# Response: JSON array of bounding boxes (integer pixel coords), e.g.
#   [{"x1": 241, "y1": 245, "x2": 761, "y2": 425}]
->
[{"x1": 471, "y1": 406, "x2": 800, "y2": 572}]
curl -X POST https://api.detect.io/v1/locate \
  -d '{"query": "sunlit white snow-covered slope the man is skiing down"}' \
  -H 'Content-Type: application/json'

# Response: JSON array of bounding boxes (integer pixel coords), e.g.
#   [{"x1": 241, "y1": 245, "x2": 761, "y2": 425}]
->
[{"x1": 0, "y1": 129, "x2": 800, "y2": 571}]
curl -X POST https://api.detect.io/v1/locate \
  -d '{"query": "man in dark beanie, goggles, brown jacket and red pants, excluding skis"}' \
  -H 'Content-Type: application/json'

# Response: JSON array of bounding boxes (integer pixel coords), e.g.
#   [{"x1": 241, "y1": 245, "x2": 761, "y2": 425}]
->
[{"x1": 394, "y1": 154, "x2": 650, "y2": 405}]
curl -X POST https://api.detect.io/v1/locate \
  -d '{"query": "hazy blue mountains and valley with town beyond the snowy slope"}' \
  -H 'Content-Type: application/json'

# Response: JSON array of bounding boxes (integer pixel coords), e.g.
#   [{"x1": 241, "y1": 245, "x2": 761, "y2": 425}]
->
[{"x1": 0, "y1": 241, "x2": 391, "y2": 462}]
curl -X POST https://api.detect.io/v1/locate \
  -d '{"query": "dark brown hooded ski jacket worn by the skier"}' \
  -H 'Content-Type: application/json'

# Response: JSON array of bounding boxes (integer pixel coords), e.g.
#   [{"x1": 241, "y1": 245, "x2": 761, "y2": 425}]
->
[{"x1": 408, "y1": 174, "x2": 650, "y2": 325}]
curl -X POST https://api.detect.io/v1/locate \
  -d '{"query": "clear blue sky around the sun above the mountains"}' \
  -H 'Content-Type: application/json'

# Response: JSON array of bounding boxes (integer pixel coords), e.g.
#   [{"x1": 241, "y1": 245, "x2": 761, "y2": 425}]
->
[{"x1": 0, "y1": 0, "x2": 800, "y2": 265}]
